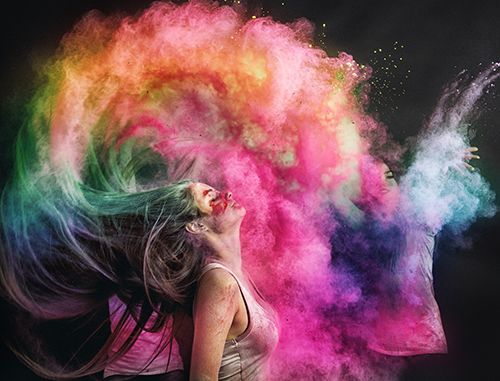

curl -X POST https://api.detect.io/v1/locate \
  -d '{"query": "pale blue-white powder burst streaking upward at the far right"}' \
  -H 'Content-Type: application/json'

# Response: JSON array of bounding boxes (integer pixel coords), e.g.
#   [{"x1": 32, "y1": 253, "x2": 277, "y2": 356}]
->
[{"x1": 401, "y1": 64, "x2": 500, "y2": 232}]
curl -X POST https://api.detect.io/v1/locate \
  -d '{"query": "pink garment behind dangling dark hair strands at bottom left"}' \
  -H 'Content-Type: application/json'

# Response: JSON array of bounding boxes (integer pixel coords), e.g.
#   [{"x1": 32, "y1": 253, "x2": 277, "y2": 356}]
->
[{"x1": 104, "y1": 295, "x2": 183, "y2": 378}]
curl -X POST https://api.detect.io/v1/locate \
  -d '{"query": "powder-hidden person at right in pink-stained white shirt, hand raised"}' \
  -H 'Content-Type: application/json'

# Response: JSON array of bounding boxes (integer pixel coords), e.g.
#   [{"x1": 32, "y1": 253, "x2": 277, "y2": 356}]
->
[{"x1": 332, "y1": 147, "x2": 479, "y2": 357}]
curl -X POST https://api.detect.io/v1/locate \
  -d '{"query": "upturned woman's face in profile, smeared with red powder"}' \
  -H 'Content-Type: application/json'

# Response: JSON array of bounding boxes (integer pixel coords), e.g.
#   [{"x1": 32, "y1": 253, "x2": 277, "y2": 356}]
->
[{"x1": 189, "y1": 183, "x2": 246, "y2": 232}]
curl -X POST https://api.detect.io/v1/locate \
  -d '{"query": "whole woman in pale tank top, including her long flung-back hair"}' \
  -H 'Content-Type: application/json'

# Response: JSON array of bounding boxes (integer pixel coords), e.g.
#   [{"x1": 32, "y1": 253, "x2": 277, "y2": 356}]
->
[{"x1": 0, "y1": 174, "x2": 277, "y2": 380}]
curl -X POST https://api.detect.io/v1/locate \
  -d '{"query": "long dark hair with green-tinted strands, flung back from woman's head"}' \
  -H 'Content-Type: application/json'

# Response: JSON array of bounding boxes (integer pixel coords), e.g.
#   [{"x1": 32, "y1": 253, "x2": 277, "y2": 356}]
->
[{"x1": 0, "y1": 122, "x2": 203, "y2": 379}]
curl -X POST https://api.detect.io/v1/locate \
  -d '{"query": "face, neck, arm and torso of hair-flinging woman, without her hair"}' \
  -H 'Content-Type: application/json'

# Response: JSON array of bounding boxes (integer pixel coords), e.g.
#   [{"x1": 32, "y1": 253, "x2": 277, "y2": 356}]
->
[{"x1": 186, "y1": 183, "x2": 278, "y2": 380}]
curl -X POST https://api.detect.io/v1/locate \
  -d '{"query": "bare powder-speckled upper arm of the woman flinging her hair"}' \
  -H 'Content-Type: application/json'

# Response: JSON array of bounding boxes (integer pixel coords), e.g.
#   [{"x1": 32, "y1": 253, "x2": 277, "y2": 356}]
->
[{"x1": 190, "y1": 269, "x2": 239, "y2": 380}]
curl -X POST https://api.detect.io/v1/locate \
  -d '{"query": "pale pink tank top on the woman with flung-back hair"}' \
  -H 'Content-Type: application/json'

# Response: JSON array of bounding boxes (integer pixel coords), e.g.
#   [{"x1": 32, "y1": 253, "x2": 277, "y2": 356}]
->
[{"x1": 200, "y1": 262, "x2": 279, "y2": 381}]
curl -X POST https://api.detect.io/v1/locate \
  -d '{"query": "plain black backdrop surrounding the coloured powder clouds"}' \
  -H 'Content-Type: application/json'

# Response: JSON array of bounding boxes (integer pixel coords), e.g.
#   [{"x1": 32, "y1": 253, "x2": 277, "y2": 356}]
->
[{"x1": 0, "y1": 0, "x2": 500, "y2": 381}]
